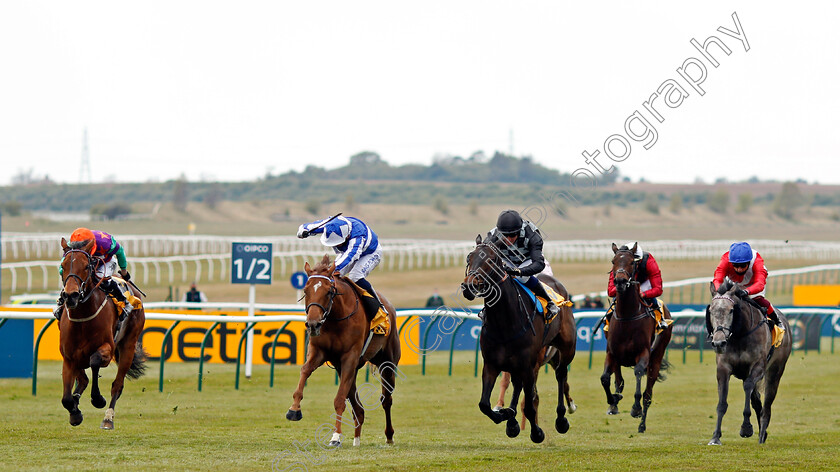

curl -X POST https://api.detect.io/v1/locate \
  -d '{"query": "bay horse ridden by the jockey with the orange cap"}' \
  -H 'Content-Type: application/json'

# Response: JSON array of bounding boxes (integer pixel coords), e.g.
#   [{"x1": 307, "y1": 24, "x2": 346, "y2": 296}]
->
[{"x1": 58, "y1": 238, "x2": 146, "y2": 429}]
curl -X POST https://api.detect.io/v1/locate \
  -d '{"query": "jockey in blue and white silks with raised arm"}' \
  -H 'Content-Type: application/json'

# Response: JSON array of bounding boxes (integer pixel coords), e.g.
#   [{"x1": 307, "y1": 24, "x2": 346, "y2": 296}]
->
[{"x1": 297, "y1": 216, "x2": 382, "y2": 300}]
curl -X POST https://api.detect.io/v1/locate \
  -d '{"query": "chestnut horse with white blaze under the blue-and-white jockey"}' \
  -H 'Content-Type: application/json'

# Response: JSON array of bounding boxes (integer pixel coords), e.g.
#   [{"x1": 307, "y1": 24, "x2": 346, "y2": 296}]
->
[{"x1": 286, "y1": 256, "x2": 400, "y2": 447}]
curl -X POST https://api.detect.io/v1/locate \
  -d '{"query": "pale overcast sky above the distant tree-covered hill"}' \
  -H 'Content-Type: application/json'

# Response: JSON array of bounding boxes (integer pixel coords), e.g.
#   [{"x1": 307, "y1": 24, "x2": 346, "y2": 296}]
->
[{"x1": 0, "y1": 1, "x2": 840, "y2": 185}]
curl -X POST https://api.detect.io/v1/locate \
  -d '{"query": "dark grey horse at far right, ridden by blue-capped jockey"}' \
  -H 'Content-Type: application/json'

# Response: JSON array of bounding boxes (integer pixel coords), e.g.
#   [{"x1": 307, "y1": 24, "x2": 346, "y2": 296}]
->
[{"x1": 706, "y1": 279, "x2": 791, "y2": 446}]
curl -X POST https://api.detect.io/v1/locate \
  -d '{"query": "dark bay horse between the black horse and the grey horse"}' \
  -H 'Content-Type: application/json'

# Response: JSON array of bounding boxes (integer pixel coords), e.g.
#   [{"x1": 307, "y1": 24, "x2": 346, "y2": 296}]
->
[{"x1": 601, "y1": 243, "x2": 672, "y2": 433}]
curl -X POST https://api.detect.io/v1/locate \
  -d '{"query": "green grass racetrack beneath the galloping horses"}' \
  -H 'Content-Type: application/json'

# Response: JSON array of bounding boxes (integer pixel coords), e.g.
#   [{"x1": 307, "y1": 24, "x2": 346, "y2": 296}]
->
[{"x1": 0, "y1": 349, "x2": 840, "y2": 471}]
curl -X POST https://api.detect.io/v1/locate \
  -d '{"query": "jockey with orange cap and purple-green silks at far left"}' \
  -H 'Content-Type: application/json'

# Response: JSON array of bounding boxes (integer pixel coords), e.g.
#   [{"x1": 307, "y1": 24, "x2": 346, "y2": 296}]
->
[{"x1": 53, "y1": 228, "x2": 133, "y2": 321}]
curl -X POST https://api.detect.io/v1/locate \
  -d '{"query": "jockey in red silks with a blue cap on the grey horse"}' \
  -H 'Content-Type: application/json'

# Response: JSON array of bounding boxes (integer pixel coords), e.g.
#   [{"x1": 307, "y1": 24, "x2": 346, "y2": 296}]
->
[{"x1": 713, "y1": 242, "x2": 785, "y2": 330}]
